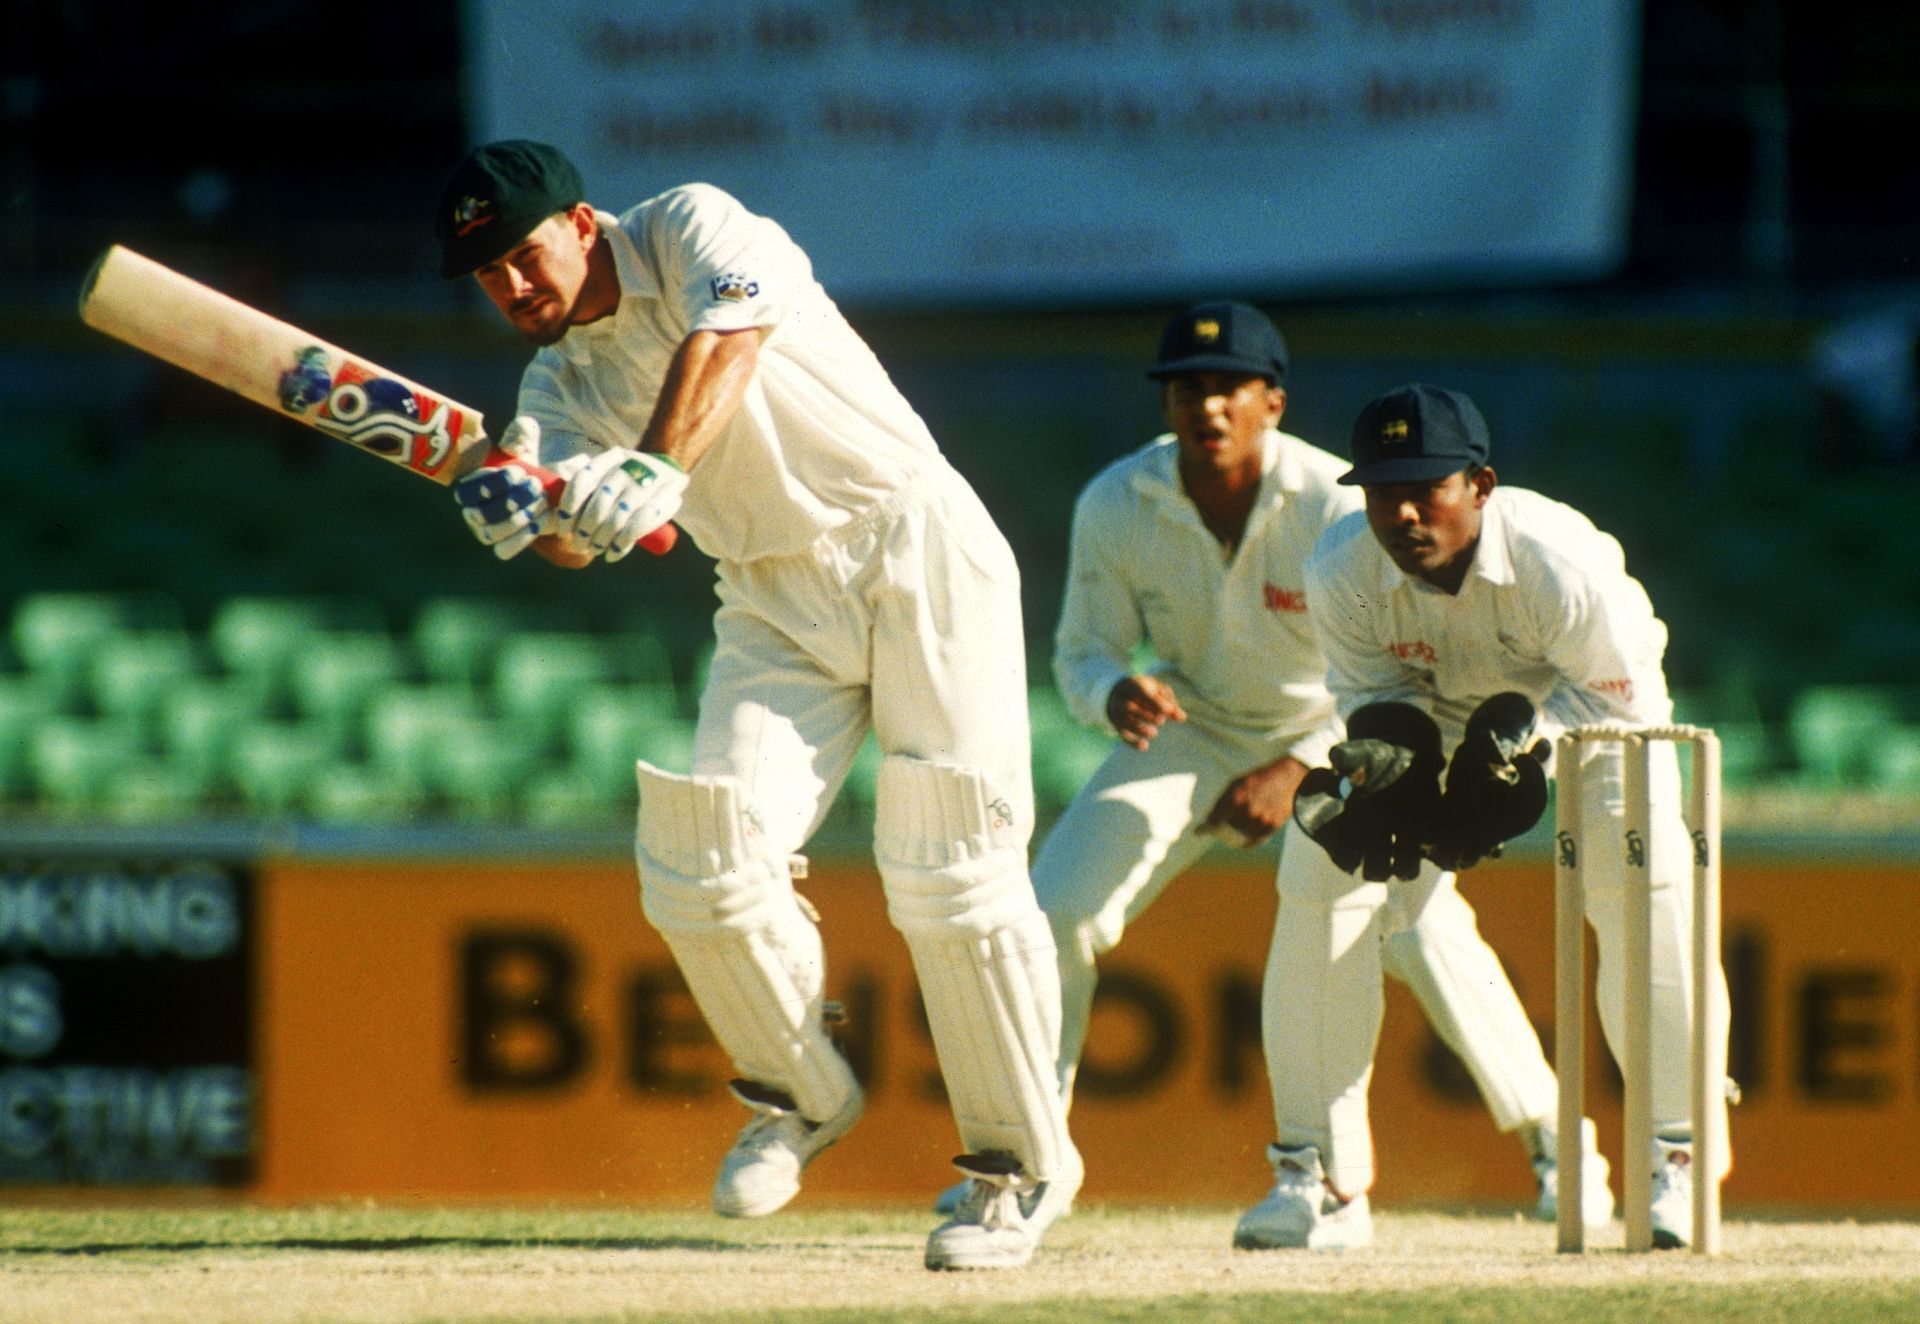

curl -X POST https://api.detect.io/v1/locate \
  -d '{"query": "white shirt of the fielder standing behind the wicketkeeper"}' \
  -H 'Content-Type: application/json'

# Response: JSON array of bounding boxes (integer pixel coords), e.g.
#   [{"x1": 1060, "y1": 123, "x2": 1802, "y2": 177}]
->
[{"x1": 1054, "y1": 430, "x2": 1359, "y2": 762}]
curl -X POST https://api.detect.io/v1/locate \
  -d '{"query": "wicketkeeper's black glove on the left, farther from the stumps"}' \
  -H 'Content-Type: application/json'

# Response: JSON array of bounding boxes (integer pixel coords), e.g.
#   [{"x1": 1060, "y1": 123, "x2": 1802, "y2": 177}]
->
[{"x1": 1294, "y1": 702, "x2": 1446, "y2": 883}]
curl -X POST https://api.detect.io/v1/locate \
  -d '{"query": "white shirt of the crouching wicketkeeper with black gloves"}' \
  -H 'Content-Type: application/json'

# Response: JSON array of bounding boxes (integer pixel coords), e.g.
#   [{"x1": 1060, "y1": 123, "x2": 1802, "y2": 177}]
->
[{"x1": 1306, "y1": 487, "x2": 1672, "y2": 748}]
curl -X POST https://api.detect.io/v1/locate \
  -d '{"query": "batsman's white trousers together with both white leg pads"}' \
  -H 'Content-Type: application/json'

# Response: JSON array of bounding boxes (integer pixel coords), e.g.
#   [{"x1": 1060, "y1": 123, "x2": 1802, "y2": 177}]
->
[{"x1": 637, "y1": 464, "x2": 1069, "y2": 1180}]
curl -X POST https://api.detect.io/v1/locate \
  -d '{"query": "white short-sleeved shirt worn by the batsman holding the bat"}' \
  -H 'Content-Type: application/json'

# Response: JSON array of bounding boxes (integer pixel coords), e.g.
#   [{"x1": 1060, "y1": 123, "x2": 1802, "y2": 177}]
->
[{"x1": 518, "y1": 184, "x2": 945, "y2": 560}]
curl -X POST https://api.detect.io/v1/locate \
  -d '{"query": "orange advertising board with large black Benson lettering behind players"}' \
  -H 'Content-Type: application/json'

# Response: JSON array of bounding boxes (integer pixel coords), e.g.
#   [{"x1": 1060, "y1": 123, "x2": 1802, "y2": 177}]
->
[{"x1": 253, "y1": 856, "x2": 1920, "y2": 1213}]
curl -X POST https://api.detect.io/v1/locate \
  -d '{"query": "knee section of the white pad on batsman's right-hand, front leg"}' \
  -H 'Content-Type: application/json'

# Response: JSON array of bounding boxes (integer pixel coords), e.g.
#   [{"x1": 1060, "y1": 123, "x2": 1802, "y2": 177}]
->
[{"x1": 874, "y1": 754, "x2": 1039, "y2": 936}]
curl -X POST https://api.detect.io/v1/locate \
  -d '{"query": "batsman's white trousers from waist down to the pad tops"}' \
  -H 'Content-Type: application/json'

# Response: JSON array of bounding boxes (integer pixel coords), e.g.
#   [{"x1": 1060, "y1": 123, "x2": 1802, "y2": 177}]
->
[{"x1": 693, "y1": 466, "x2": 1033, "y2": 836}]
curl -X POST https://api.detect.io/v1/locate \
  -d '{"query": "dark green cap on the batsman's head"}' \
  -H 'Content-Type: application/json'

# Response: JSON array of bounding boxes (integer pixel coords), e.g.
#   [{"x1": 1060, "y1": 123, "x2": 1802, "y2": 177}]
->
[{"x1": 434, "y1": 138, "x2": 588, "y2": 280}]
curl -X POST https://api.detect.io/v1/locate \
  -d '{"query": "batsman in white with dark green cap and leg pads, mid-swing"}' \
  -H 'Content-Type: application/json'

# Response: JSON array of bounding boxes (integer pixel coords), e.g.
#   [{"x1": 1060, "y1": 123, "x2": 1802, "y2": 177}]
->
[{"x1": 434, "y1": 140, "x2": 1081, "y2": 1268}]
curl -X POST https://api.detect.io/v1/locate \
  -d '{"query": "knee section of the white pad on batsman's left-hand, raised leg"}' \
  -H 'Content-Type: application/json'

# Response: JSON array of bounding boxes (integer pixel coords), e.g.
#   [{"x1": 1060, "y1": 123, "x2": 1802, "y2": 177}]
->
[{"x1": 634, "y1": 764, "x2": 793, "y2": 931}]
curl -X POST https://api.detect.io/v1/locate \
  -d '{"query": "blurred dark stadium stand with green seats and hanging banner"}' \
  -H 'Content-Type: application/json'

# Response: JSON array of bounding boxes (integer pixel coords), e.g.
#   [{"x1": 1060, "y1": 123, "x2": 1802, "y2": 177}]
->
[{"x1": 0, "y1": 0, "x2": 1920, "y2": 1212}]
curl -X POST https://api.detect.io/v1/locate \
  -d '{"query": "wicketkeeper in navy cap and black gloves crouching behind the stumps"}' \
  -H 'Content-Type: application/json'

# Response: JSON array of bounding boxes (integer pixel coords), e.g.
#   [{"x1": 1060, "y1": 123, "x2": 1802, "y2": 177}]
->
[{"x1": 1277, "y1": 386, "x2": 1730, "y2": 1247}]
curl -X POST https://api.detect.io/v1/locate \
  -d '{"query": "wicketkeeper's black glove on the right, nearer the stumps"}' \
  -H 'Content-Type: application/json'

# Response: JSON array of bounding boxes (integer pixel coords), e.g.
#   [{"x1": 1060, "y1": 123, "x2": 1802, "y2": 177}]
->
[{"x1": 1428, "y1": 691, "x2": 1549, "y2": 869}]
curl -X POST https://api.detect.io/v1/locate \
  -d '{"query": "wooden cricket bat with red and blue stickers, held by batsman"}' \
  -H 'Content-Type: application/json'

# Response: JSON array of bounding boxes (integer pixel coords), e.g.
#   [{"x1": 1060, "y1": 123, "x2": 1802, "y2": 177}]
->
[{"x1": 81, "y1": 244, "x2": 680, "y2": 556}]
